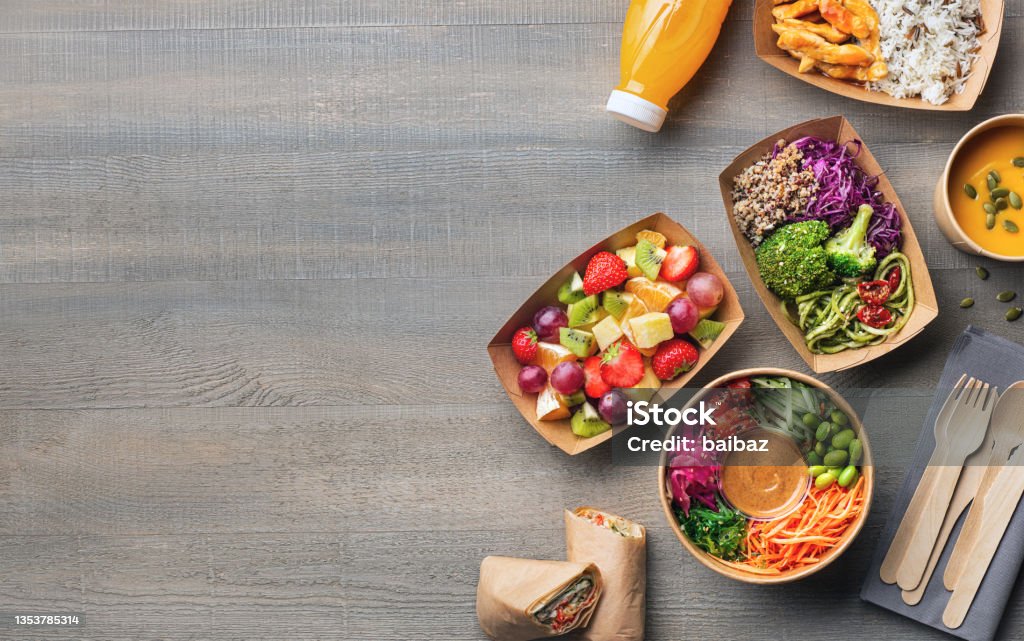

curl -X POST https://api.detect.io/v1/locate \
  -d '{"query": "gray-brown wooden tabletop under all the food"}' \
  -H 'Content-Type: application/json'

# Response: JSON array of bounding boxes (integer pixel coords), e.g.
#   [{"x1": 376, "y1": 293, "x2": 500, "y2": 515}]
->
[{"x1": 0, "y1": 0, "x2": 1024, "y2": 641}]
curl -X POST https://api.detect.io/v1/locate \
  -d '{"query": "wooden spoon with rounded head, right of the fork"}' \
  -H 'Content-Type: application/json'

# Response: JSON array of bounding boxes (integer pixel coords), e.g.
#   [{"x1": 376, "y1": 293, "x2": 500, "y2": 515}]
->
[{"x1": 942, "y1": 381, "x2": 1024, "y2": 590}]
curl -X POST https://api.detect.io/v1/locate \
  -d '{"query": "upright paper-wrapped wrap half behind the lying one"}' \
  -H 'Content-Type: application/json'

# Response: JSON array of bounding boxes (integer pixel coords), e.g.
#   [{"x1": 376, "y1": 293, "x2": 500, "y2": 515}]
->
[{"x1": 565, "y1": 507, "x2": 647, "y2": 641}]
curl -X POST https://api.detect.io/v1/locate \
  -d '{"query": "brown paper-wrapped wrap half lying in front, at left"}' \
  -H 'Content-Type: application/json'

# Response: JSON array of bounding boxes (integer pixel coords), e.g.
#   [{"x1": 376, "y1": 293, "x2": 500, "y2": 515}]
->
[{"x1": 476, "y1": 556, "x2": 602, "y2": 641}]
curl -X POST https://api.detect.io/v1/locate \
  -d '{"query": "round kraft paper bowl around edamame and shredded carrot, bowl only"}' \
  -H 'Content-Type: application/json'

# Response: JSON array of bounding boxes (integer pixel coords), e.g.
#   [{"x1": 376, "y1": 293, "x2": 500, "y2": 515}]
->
[{"x1": 657, "y1": 368, "x2": 874, "y2": 585}]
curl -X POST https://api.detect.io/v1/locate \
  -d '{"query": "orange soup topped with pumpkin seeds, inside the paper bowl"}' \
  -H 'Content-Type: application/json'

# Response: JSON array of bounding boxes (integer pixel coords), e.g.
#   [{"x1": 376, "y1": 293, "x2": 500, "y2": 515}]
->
[{"x1": 949, "y1": 126, "x2": 1024, "y2": 256}]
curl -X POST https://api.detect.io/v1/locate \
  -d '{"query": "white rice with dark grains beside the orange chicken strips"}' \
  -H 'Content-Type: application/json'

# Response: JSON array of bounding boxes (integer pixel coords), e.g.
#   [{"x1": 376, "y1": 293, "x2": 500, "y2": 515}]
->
[{"x1": 869, "y1": 0, "x2": 981, "y2": 104}]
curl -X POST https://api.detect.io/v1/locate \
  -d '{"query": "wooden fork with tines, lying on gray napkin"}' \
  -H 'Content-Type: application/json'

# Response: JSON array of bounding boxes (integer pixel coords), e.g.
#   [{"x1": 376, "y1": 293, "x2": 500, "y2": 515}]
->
[{"x1": 896, "y1": 381, "x2": 998, "y2": 590}]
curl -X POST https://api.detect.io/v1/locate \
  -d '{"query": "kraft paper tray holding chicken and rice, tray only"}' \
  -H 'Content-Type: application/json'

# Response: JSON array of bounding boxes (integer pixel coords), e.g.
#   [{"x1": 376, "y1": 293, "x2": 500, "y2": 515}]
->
[{"x1": 754, "y1": 0, "x2": 1004, "y2": 112}]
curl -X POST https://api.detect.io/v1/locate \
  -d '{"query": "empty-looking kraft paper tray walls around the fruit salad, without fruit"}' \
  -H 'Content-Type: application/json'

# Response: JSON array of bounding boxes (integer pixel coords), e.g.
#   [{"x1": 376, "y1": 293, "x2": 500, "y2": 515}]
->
[{"x1": 487, "y1": 213, "x2": 743, "y2": 455}]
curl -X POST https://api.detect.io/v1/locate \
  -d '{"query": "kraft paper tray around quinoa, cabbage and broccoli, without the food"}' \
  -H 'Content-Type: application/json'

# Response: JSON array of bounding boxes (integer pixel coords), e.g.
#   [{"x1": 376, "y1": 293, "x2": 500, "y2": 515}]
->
[{"x1": 719, "y1": 116, "x2": 939, "y2": 374}]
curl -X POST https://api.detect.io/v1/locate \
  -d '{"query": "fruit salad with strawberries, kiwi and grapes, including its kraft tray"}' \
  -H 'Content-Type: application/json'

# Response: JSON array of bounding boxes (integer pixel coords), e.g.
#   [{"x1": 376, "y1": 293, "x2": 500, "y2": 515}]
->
[{"x1": 487, "y1": 213, "x2": 743, "y2": 455}]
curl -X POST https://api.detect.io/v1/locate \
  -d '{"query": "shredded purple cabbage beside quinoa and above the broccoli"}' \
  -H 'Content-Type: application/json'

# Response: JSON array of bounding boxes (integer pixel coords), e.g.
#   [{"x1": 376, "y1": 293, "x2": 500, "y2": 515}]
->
[{"x1": 775, "y1": 136, "x2": 903, "y2": 258}]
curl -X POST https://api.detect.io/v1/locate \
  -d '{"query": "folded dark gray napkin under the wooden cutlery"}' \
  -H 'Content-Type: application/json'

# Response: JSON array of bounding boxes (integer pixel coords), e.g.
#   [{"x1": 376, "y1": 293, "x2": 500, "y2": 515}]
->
[{"x1": 860, "y1": 327, "x2": 1024, "y2": 641}]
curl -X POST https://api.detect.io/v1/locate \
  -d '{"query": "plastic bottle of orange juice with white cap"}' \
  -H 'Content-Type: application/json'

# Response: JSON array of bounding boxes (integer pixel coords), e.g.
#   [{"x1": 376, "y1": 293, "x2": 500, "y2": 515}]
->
[{"x1": 606, "y1": 0, "x2": 732, "y2": 131}]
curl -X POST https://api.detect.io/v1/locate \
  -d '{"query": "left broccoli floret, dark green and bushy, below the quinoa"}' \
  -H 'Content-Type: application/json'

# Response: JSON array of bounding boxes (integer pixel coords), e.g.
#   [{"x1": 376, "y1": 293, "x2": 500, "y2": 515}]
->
[{"x1": 755, "y1": 220, "x2": 836, "y2": 299}]
